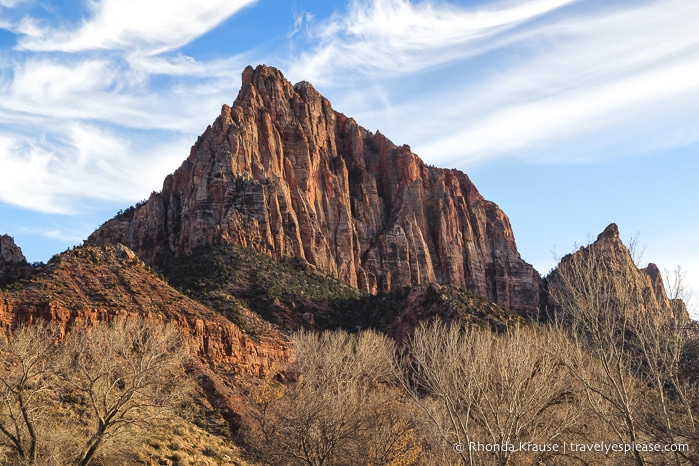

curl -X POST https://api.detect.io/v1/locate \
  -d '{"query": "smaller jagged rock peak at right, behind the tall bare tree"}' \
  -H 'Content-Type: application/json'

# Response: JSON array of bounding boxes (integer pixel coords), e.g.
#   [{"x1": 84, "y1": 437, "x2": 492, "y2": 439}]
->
[{"x1": 543, "y1": 223, "x2": 690, "y2": 323}]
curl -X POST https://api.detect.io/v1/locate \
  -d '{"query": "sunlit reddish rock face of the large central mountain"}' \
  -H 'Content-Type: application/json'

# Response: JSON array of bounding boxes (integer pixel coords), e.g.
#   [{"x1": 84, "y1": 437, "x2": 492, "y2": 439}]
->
[{"x1": 88, "y1": 66, "x2": 540, "y2": 311}]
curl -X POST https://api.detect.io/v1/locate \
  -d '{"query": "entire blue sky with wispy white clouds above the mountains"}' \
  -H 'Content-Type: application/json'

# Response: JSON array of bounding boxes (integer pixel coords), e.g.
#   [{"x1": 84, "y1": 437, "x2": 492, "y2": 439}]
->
[{"x1": 0, "y1": 0, "x2": 699, "y2": 314}]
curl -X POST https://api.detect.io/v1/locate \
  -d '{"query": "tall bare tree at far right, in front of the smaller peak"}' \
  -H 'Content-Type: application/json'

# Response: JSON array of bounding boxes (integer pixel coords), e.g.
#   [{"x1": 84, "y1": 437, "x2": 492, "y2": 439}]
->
[{"x1": 548, "y1": 241, "x2": 693, "y2": 465}]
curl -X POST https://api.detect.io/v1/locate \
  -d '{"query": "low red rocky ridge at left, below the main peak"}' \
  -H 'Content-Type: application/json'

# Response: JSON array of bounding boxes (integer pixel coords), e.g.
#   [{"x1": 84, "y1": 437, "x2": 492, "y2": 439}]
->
[{"x1": 0, "y1": 245, "x2": 292, "y2": 376}]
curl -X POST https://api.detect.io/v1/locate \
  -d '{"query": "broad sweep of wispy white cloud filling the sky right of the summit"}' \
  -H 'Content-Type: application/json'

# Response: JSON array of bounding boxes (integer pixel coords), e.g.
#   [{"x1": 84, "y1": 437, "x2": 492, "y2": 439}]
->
[{"x1": 292, "y1": 0, "x2": 699, "y2": 167}]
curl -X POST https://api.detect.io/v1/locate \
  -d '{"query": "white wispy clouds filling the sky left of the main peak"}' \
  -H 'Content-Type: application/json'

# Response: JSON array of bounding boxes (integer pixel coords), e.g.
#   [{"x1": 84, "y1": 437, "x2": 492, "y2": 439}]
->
[{"x1": 0, "y1": 0, "x2": 255, "y2": 215}]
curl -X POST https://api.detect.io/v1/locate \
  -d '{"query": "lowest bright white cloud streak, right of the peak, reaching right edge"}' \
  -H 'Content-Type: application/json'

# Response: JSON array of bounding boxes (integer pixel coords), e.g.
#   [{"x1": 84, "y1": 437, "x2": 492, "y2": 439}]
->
[{"x1": 428, "y1": 56, "x2": 699, "y2": 163}]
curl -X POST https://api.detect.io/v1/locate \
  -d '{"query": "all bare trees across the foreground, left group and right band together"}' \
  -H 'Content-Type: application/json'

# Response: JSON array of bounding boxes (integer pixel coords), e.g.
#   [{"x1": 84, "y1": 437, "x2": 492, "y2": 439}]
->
[{"x1": 0, "y1": 238, "x2": 699, "y2": 466}]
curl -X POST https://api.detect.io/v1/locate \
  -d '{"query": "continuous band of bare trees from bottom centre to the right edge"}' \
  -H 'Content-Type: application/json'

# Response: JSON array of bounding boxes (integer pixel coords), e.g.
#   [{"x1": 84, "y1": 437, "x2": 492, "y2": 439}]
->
[{"x1": 247, "y1": 242, "x2": 699, "y2": 466}]
